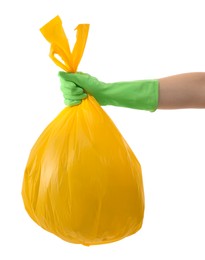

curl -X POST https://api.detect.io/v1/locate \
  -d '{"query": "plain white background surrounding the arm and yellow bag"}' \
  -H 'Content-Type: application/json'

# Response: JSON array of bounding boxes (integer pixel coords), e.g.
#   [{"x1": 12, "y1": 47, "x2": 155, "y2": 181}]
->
[{"x1": 0, "y1": 0, "x2": 205, "y2": 260}]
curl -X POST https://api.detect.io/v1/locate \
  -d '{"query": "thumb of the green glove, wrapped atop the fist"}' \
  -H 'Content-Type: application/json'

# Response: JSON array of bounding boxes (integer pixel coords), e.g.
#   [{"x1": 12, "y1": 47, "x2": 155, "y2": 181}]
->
[{"x1": 58, "y1": 71, "x2": 89, "y2": 88}]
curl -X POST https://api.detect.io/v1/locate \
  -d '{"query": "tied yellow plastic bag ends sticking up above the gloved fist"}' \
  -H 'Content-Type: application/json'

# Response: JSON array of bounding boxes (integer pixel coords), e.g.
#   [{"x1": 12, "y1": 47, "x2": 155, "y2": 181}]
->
[{"x1": 40, "y1": 16, "x2": 89, "y2": 72}]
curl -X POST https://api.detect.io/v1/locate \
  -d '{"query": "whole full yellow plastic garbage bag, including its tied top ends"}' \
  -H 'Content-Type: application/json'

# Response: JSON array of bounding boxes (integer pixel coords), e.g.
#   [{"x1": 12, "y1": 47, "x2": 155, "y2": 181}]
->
[{"x1": 22, "y1": 16, "x2": 144, "y2": 246}]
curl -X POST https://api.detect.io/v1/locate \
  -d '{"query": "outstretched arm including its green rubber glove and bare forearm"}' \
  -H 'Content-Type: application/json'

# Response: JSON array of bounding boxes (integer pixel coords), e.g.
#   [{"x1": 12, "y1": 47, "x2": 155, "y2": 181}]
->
[{"x1": 59, "y1": 72, "x2": 205, "y2": 112}]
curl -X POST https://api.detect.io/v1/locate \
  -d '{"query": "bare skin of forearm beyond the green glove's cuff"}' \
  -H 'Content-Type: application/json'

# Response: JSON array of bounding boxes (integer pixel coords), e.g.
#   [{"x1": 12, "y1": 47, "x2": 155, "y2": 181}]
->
[{"x1": 158, "y1": 72, "x2": 205, "y2": 109}]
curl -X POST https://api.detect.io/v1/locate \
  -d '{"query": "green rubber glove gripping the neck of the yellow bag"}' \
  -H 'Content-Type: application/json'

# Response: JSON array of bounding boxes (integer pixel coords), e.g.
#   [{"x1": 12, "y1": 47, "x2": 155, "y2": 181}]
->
[{"x1": 58, "y1": 71, "x2": 159, "y2": 112}]
